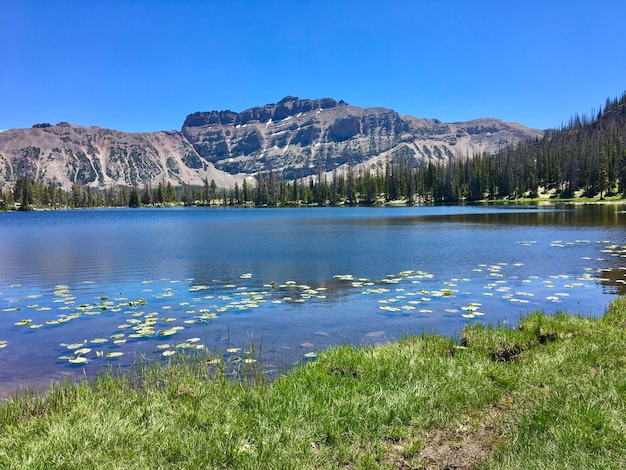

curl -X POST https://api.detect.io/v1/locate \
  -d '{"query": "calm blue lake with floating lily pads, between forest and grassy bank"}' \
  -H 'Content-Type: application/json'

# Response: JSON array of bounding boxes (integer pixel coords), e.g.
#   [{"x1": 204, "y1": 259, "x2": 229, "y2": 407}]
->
[{"x1": 0, "y1": 205, "x2": 626, "y2": 395}]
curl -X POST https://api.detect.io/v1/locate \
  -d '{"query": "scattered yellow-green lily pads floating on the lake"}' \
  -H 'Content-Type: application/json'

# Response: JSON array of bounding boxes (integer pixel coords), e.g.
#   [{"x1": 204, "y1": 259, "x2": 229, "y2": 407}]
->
[{"x1": 0, "y1": 240, "x2": 626, "y2": 380}]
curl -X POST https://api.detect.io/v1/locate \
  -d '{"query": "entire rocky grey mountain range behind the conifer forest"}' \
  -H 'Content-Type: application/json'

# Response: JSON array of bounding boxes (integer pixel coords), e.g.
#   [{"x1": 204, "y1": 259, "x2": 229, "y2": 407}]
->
[{"x1": 0, "y1": 96, "x2": 543, "y2": 189}]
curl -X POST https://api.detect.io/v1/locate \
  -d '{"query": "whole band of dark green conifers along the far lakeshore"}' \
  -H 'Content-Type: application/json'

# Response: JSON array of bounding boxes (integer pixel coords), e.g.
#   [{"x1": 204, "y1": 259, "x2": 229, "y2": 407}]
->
[{"x1": 0, "y1": 92, "x2": 626, "y2": 209}]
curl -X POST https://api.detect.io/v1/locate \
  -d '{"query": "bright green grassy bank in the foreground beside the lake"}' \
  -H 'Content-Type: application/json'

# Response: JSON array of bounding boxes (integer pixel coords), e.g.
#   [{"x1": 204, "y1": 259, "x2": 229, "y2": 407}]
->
[{"x1": 0, "y1": 299, "x2": 626, "y2": 469}]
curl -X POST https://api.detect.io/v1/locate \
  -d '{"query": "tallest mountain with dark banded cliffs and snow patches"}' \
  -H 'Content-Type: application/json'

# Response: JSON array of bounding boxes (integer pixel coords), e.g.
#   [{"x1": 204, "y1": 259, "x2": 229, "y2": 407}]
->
[{"x1": 182, "y1": 96, "x2": 543, "y2": 178}]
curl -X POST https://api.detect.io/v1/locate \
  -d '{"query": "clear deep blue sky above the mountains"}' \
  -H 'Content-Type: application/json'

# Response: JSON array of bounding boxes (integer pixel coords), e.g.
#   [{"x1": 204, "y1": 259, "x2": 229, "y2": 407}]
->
[{"x1": 0, "y1": 0, "x2": 626, "y2": 131}]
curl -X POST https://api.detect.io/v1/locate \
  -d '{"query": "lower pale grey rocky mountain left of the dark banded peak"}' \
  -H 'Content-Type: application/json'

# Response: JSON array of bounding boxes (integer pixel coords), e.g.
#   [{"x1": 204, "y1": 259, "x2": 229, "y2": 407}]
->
[{"x1": 0, "y1": 123, "x2": 241, "y2": 193}]
